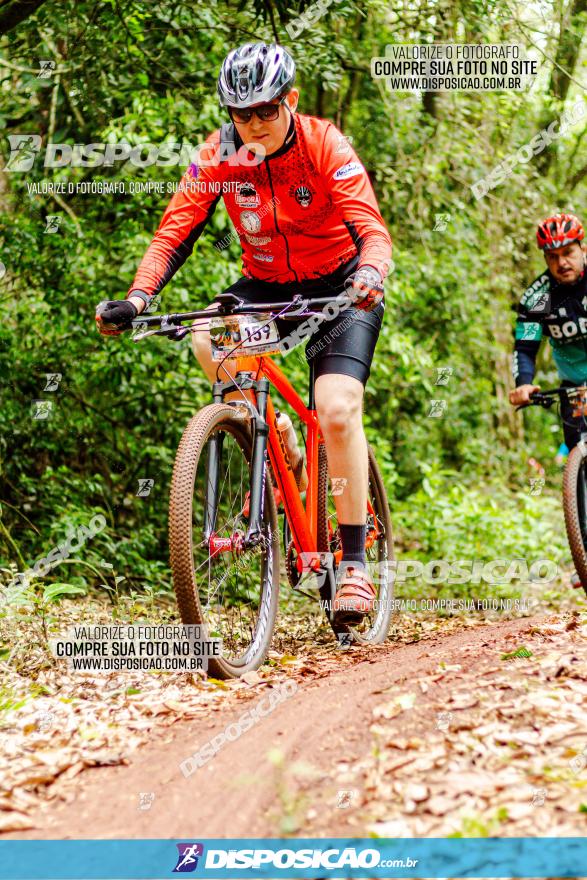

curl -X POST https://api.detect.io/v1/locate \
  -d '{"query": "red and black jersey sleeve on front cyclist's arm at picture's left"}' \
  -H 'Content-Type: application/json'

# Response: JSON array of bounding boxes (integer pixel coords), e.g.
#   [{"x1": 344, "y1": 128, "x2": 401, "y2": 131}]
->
[{"x1": 127, "y1": 132, "x2": 224, "y2": 298}]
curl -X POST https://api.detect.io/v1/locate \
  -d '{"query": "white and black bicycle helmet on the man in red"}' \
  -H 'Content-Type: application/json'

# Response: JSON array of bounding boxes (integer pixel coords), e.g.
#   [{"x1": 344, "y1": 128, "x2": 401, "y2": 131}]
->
[{"x1": 218, "y1": 43, "x2": 296, "y2": 108}]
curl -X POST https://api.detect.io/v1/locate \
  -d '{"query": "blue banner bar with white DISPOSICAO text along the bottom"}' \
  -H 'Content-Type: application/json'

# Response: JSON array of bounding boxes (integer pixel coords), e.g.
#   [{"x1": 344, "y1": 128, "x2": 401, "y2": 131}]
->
[{"x1": 0, "y1": 837, "x2": 587, "y2": 880}]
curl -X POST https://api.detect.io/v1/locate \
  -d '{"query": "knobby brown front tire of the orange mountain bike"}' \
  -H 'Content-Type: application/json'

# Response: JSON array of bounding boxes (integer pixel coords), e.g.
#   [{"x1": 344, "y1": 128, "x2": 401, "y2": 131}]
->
[{"x1": 169, "y1": 403, "x2": 280, "y2": 678}]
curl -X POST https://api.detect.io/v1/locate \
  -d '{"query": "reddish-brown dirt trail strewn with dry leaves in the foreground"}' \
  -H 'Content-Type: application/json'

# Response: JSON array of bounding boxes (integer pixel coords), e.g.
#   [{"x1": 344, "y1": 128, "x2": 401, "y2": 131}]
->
[{"x1": 5, "y1": 616, "x2": 587, "y2": 839}]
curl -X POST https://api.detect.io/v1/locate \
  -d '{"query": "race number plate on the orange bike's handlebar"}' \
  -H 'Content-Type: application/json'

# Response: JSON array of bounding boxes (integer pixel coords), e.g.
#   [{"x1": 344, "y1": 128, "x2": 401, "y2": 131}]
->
[{"x1": 210, "y1": 313, "x2": 281, "y2": 361}]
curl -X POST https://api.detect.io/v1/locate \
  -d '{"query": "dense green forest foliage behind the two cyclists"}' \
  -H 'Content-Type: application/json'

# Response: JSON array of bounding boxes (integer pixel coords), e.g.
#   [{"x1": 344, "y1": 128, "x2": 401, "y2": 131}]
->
[{"x1": 0, "y1": 0, "x2": 585, "y2": 620}]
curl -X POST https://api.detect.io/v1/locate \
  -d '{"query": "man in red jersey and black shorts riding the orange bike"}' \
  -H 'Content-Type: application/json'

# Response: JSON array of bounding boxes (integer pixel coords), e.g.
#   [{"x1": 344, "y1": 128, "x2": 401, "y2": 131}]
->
[{"x1": 96, "y1": 43, "x2": 391, "y2": 618}]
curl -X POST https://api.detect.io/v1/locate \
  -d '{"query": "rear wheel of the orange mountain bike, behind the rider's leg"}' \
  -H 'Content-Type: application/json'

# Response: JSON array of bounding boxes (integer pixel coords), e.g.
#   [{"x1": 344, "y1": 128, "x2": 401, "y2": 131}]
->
[{"x1": 318, "y1": 445, "x2": 395, "y2": 645}]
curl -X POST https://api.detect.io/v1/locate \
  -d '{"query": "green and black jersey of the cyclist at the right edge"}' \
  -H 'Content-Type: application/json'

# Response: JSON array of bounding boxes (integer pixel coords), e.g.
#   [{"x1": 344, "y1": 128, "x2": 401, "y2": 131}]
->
[{"x1": 512, "y1": 272, "x2": 587, "y2": 387}]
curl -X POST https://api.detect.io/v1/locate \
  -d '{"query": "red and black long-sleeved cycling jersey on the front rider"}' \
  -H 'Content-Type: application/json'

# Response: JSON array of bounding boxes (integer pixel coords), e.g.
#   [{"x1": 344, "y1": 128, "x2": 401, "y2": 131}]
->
[{"x1": 129, "y1": 114, "x2": 391, "y2": 296}]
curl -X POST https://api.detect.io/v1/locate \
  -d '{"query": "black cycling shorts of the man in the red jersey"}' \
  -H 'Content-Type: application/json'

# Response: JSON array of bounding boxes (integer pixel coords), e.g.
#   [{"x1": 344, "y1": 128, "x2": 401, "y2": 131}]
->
[{"x1": 218, "y1": 258, "x2": 385, "y2": 385}]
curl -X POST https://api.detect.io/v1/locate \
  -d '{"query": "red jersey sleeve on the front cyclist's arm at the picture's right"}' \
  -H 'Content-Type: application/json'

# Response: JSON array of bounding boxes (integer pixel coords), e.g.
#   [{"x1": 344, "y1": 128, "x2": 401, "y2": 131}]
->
[{"x1": 321, "y1": 124, "x2": 391, "y2": 278}]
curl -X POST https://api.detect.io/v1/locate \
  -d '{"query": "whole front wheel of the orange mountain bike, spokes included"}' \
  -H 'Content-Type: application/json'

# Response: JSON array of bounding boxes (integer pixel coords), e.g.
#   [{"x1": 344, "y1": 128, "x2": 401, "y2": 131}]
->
[{"x1": 169, "y1": 404, "x2": 279, "y2": 678}]
